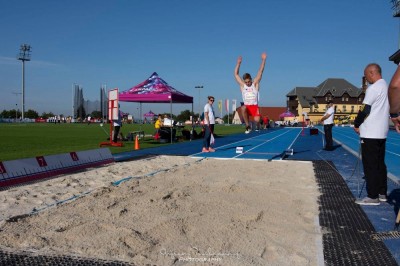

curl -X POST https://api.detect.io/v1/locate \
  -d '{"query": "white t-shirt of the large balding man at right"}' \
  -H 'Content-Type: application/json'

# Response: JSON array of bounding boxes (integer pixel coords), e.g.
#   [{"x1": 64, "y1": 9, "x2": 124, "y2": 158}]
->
[{"x1": 360, "y1": 79, "x2": 389, "y2": 139}]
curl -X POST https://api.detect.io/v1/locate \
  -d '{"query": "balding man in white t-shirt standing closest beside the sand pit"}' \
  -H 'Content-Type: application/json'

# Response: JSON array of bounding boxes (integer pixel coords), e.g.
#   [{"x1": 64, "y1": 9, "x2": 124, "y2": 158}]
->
[{"x1": 354, "y1": 64, "x2": 389, "y2": 205}]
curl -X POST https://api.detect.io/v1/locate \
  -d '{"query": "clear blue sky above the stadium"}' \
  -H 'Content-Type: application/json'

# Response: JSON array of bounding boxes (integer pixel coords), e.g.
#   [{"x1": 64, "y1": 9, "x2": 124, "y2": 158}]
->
[{"x1": 0, "y1": 0, "x2": 399, "y2": 116}]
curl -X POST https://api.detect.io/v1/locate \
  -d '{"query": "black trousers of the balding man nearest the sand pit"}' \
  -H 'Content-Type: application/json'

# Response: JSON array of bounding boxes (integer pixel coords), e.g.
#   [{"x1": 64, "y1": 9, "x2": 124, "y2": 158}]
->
[{"x1": 361, "y1": 138, "x2": 387, "y2": 199}]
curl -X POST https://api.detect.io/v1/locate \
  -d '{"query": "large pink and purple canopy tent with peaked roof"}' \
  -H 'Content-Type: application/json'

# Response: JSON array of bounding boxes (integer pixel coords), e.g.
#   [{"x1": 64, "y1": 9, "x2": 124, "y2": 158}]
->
[{"x1": 119, "y1": 72, "x2": 193, "y2": 142}]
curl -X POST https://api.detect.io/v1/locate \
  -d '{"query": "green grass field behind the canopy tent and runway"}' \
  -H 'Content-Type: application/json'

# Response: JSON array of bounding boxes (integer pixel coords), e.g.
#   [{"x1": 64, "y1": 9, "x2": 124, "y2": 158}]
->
[{"x1": 0, "y1": 123, "x2": 244, "y2": 161}]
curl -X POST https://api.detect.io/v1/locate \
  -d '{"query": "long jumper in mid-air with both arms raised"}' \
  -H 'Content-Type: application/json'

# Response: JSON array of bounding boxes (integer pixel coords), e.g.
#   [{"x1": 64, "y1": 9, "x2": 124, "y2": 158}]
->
[{"x1": 235, "y1": 52, "x2": 267, "y2": 134}]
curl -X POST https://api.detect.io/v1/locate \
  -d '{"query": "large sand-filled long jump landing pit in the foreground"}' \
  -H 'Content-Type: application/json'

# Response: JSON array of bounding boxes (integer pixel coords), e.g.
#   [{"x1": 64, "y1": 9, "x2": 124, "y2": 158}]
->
[{"x1": 0, "y1": 156, "x2": 321, "y2": 265}]
